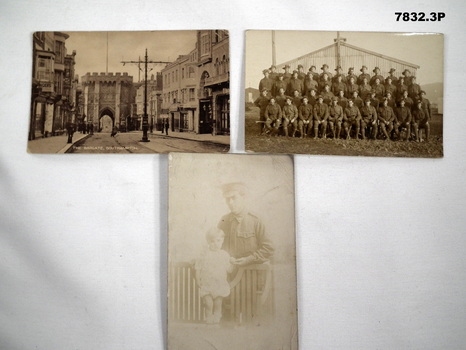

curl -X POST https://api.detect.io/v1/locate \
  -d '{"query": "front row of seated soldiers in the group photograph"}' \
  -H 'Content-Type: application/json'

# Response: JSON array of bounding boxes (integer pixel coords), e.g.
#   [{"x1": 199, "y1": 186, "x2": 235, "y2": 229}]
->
[{"x1": 254, "y1": 88, "x2": 432, "y2": 142}]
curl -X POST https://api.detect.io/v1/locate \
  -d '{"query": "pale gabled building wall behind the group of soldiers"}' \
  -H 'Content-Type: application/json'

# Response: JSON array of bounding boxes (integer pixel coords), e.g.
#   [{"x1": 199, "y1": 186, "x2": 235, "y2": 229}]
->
[{"x1": 278, "y1": 35, "x2": 420, "y2": 77}]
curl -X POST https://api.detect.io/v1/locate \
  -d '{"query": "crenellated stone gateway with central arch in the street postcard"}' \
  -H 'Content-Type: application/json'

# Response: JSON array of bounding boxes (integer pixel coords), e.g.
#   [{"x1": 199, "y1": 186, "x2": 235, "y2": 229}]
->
[{"x1": 81, "y1": 73, "x2": 135, "y2": 132}]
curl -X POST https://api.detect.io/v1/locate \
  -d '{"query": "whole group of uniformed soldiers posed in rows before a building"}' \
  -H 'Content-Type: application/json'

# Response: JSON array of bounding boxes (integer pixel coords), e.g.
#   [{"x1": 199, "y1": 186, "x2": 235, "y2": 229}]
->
[{"x1": 254, "y1": 64, "x2": 432, "y2": 142}]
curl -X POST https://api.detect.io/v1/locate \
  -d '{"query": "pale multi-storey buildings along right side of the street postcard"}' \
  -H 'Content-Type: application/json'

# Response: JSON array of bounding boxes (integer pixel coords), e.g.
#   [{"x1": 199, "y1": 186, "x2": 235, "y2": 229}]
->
[{"x1": 161, "y1": 30, "x2": 230, "y2": 134}]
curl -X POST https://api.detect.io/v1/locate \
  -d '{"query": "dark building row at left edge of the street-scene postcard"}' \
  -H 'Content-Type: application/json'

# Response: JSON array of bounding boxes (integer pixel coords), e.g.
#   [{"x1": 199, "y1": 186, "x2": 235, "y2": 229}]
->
[{"x1": 29, "y1": 32, "x2": 76, "y2": 140}]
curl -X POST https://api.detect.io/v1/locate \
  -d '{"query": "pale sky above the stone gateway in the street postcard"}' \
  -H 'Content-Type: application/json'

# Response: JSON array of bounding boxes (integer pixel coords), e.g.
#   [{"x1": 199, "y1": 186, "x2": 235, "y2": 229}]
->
[{"x1": 62, "y1": 30, "x2": 196, "y2": 82}]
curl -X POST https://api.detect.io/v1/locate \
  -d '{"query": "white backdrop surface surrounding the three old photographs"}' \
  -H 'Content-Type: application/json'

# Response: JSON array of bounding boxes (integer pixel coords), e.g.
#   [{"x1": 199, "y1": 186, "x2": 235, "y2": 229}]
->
[{"x1": 0, "y1": 0, "x2": 466, "y2": 350}]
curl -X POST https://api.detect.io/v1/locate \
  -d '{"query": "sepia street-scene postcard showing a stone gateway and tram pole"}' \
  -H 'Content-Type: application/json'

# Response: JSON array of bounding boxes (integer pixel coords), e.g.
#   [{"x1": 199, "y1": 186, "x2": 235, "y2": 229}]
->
[{"x1": 27, "y1": 30, "x2": 230, "y2": 153}]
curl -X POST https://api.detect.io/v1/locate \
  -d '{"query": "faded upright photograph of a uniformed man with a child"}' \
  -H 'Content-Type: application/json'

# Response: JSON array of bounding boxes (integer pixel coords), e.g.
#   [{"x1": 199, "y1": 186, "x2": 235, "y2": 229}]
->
[{"x1": 168, "y1": 153, "x2": 298, "y2": 350}]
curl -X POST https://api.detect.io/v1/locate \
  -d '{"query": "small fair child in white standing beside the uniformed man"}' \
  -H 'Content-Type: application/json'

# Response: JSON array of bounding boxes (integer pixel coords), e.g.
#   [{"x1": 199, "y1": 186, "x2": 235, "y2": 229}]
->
[{"x1": 195, "y1": 227, "x2": 234, "y2": 324}]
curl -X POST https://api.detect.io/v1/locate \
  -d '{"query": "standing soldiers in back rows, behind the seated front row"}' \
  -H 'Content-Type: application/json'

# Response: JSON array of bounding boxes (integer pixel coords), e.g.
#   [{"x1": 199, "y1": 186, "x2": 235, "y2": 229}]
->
[{"x1": 259, "y1": 64, "x2": 421, "y2": 100}]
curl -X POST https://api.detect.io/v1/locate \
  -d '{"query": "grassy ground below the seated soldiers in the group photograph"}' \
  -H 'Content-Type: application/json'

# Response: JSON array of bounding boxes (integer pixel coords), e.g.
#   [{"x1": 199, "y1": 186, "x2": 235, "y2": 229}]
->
[{"x1": 245, "y1": 106, "x2": 443, "y2": 158}]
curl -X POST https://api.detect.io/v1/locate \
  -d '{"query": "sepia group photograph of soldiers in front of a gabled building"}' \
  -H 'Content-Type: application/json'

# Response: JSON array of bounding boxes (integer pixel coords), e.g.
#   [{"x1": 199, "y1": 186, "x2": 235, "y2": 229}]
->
[{"x1": 245, "y1": 30, "x2": 444, "y2": 158}]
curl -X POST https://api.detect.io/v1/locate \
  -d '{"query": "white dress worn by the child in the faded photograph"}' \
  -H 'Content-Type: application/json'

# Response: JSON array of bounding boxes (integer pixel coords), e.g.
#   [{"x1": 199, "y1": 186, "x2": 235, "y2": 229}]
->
[{"x1": 195, "y1": 249, "x2": 230, "y2": 298}]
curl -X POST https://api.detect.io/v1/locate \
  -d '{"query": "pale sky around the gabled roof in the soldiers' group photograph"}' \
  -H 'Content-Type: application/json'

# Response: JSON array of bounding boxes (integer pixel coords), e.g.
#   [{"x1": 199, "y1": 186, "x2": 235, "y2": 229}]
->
[{"x1": 245, "y1": 30, "x2": 444, "y2": 88}]
